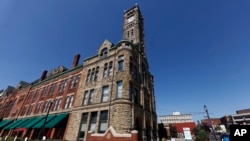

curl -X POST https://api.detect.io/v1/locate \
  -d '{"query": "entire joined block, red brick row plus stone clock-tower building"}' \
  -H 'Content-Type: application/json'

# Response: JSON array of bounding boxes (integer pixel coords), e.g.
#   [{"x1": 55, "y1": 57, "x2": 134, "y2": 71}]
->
[{"x1": 0, "y1": 5, "x2": 157, "y2": 141}]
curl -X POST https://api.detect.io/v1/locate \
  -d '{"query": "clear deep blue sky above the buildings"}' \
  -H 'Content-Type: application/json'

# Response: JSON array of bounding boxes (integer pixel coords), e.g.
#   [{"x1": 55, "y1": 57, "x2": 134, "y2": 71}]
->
[{"x1": 0, "y1": 0, "x2": 250, "y2": 120}]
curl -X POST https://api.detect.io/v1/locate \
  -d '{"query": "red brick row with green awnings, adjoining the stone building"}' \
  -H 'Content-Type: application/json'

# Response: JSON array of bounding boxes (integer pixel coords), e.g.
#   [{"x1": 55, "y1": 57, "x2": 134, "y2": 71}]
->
[{"x1": 0, "y1": 55, "x2": 82, "y2": 139}]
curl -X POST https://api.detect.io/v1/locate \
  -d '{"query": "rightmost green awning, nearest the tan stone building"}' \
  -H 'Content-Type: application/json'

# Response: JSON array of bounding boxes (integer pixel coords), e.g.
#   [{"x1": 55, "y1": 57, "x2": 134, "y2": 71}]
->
[{"x1": 45, "y1": 113, "x2": 69, "y2": 128}]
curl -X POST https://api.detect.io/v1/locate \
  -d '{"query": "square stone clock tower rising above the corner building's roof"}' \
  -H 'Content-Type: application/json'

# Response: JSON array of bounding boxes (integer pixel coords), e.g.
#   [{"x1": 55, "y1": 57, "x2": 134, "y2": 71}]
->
[{"x1": 123, "y1": 4, "x2": 146, "y2": 56}]
